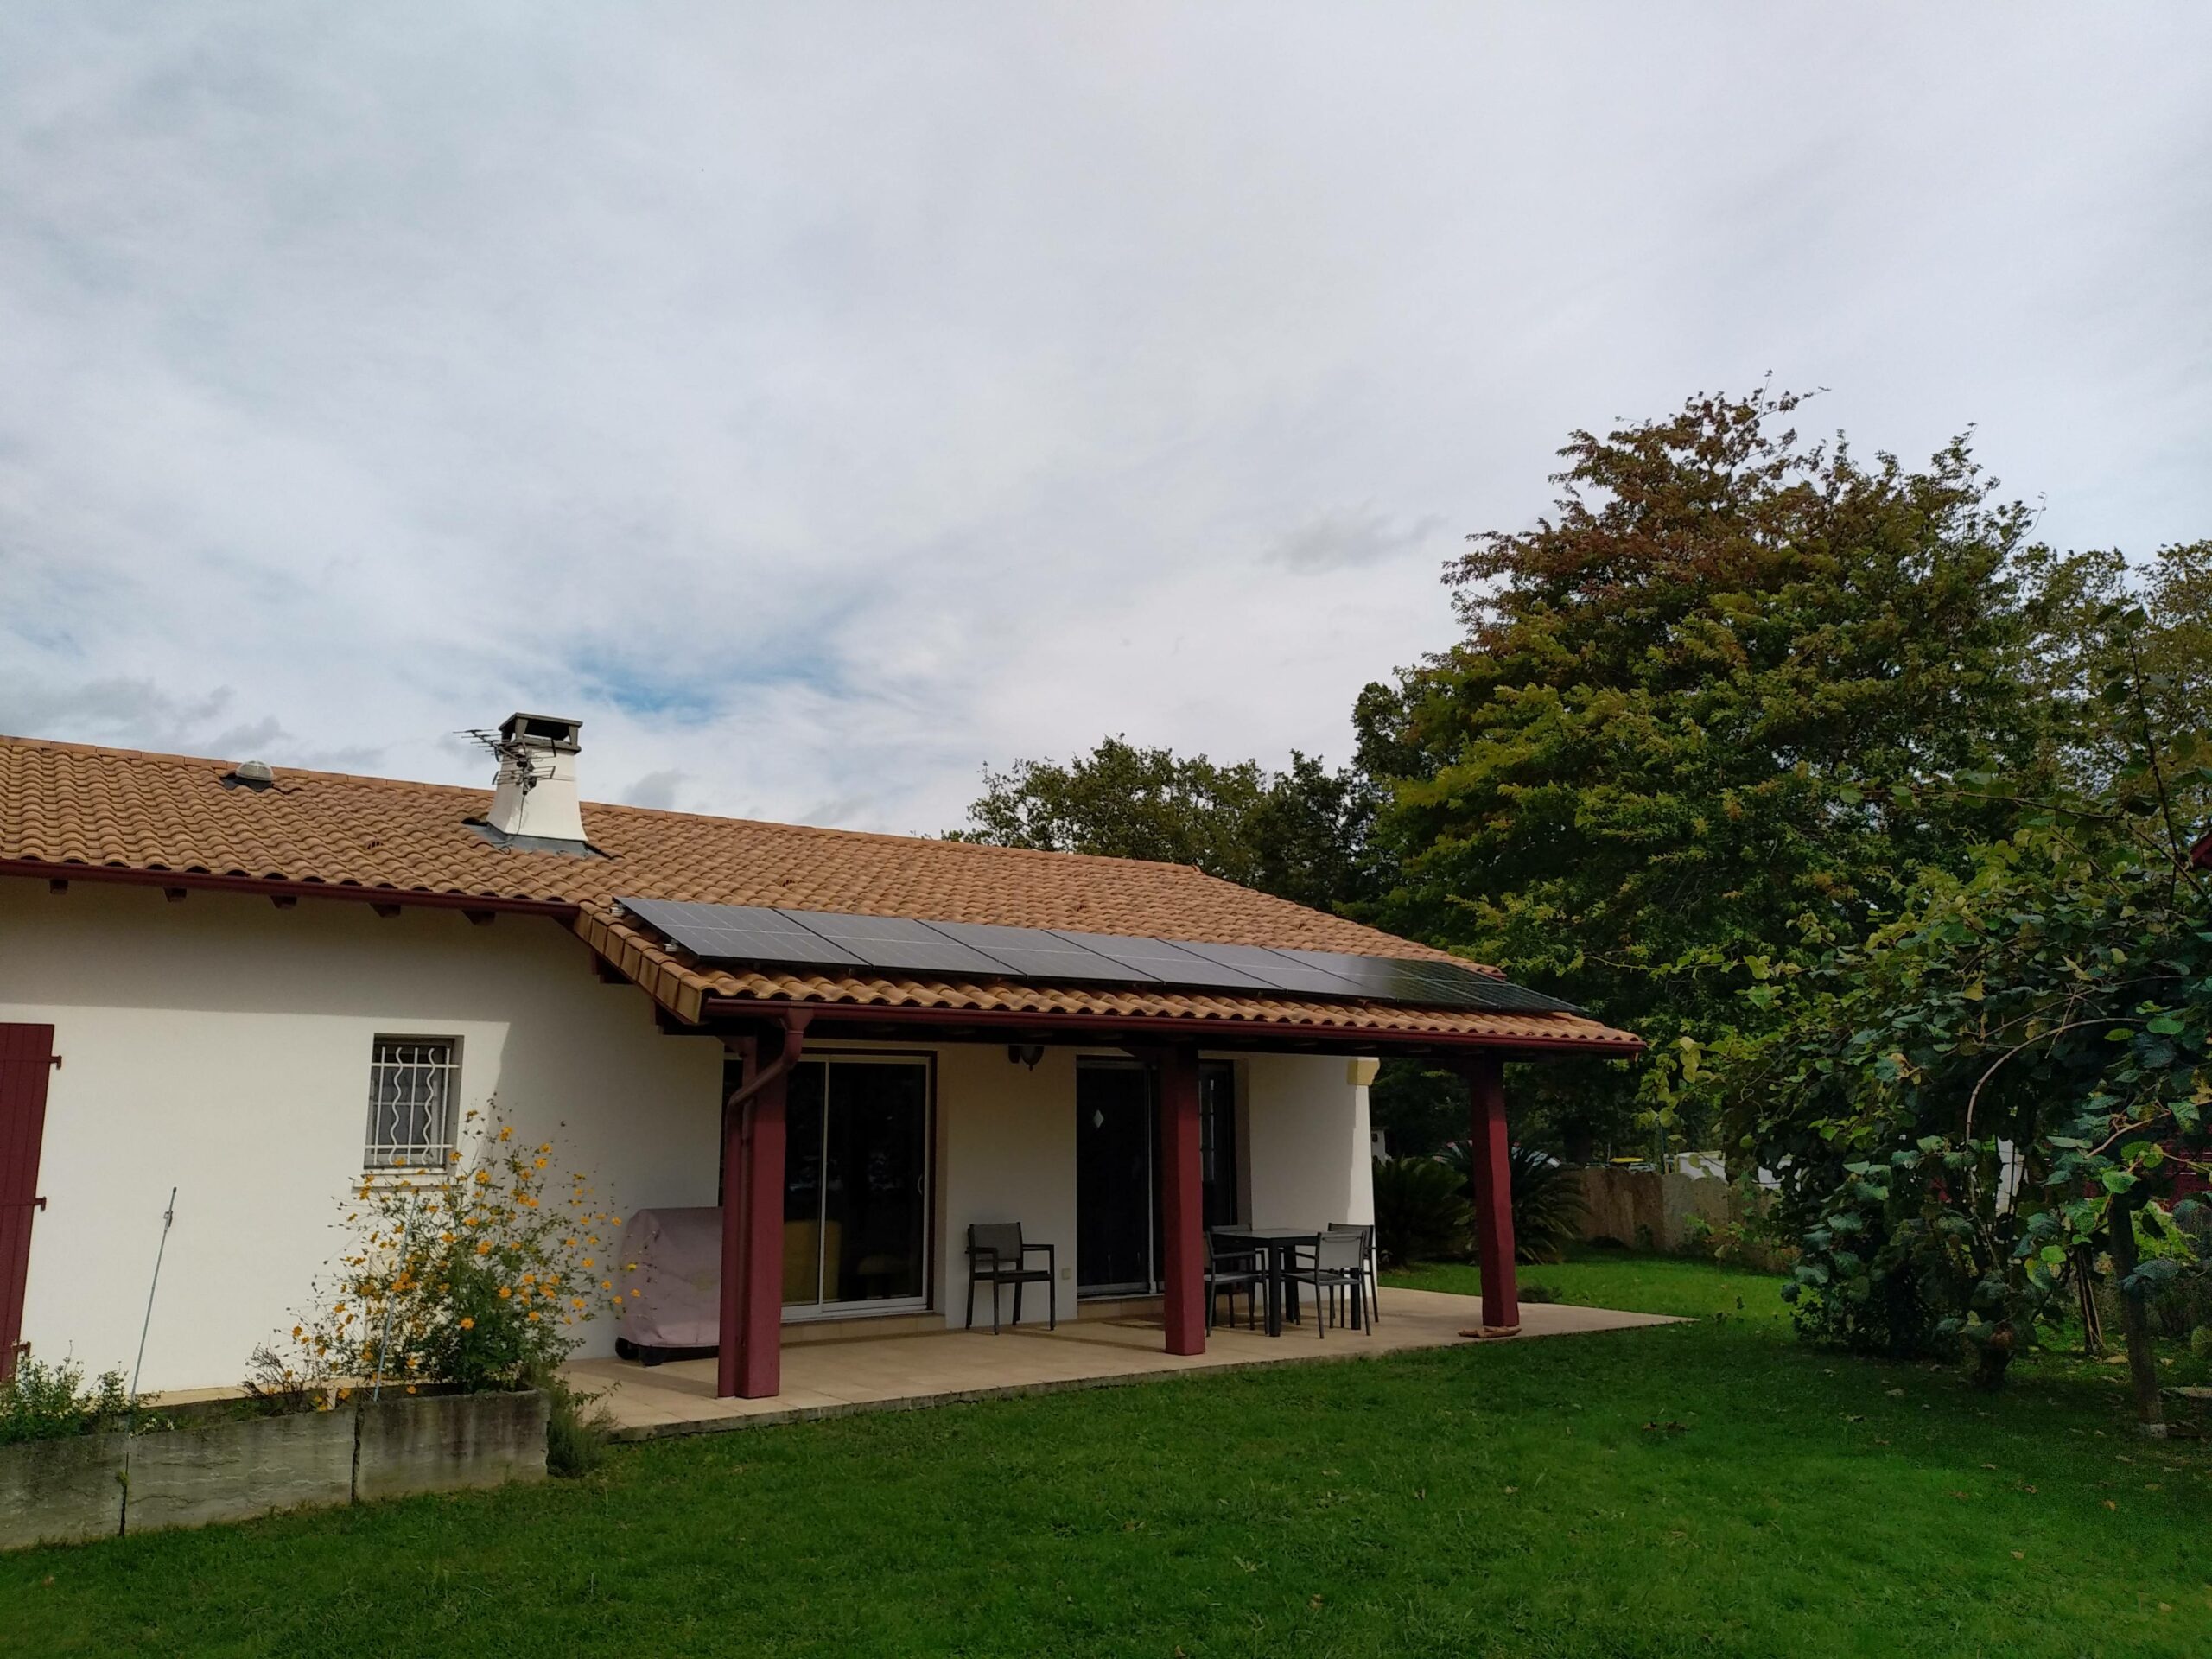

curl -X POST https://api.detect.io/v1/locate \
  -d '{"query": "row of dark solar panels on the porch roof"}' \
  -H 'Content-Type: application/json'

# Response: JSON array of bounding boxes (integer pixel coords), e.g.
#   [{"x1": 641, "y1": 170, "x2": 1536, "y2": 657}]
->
[{"x1": 617, "y1": 898, "x2": 1581, "y2": 1013}]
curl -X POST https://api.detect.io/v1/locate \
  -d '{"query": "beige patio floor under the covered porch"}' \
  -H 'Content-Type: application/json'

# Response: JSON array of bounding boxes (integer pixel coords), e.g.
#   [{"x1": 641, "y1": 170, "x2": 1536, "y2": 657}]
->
[{"x1": 569, "y1": 1287, "x2": 1679, "y2": 1440}]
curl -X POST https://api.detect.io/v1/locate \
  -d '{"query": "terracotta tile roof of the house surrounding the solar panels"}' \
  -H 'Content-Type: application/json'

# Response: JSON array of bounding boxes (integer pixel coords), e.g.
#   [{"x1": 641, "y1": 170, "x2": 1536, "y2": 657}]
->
[{"x1": 0, "y1": 736, "x2": 1635, "y2": 1046}]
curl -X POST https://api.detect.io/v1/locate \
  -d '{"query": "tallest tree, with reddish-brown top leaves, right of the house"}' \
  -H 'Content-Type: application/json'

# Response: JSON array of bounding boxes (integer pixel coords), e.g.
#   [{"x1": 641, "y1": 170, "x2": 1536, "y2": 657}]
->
[{"x1": 1358, "y1": 391, "x2": 2079, "y2": 1153}]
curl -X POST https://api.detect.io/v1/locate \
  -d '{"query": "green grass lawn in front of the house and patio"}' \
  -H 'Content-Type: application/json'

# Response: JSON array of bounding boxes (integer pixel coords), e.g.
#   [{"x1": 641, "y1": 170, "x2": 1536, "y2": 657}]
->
[{"x1": 0, "y1": 1256, "x2": 2212, "y2": 1659}]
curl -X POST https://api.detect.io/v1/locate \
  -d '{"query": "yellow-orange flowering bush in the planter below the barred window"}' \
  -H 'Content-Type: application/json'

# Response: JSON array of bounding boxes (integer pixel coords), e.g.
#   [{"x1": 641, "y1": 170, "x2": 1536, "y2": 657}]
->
[{"x1": 248, "y1": 1103, "x2": 635, "y2": 1409}]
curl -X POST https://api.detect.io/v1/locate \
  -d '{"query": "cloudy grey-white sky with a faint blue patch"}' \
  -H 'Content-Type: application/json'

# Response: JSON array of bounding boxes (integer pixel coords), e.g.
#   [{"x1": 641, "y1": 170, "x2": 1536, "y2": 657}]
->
[{"x1": 0, "y1": 0, "x2": 2212, "y2": 832}]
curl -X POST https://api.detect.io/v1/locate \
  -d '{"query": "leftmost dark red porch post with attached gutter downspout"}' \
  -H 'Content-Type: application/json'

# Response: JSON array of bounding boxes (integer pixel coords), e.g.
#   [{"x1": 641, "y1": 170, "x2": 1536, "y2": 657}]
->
[{"x1": 715, "y1": 1011, "x2": 807, "y2": 1400}]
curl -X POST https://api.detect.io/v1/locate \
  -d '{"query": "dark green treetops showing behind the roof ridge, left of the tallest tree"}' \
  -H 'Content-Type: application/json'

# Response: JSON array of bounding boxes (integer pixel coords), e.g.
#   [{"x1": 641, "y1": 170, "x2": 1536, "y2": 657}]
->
[{"x1": 951, "y1": 736, "x2": 1374, "y2": 909}]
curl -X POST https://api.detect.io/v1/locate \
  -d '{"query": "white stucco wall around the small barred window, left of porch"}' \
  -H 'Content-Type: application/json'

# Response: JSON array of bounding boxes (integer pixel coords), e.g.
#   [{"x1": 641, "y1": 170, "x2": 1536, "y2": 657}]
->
[{"x1": 0, "y1": 880, "x2": 721, "y2": 1389}]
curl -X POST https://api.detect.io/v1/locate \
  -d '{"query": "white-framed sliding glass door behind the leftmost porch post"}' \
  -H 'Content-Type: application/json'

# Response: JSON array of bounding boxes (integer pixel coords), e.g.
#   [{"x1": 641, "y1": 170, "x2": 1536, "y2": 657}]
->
[{"x1": 783, "y1": 1055, "x2": 931, "y2": 1319}]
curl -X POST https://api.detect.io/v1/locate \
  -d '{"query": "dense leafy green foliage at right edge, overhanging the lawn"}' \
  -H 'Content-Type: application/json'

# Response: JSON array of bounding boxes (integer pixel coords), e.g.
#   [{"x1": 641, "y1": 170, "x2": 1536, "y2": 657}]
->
[{"x1": 1734, "y1": 613, "x2": 2212, "y2": 1429}]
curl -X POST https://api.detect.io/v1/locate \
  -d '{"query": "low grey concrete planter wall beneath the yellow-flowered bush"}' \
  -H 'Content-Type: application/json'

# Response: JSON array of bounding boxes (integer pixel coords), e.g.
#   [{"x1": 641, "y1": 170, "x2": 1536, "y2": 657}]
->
[{"x1": 0, "y1": 1394, "x2": 546, "y2": 1548}]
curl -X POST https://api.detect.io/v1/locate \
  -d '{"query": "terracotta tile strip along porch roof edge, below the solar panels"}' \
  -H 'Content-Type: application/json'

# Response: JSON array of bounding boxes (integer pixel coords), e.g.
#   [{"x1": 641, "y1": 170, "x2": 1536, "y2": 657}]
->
[{"x1": 575, "y1": 905, "x2": 1643, "y2": 1058}]
